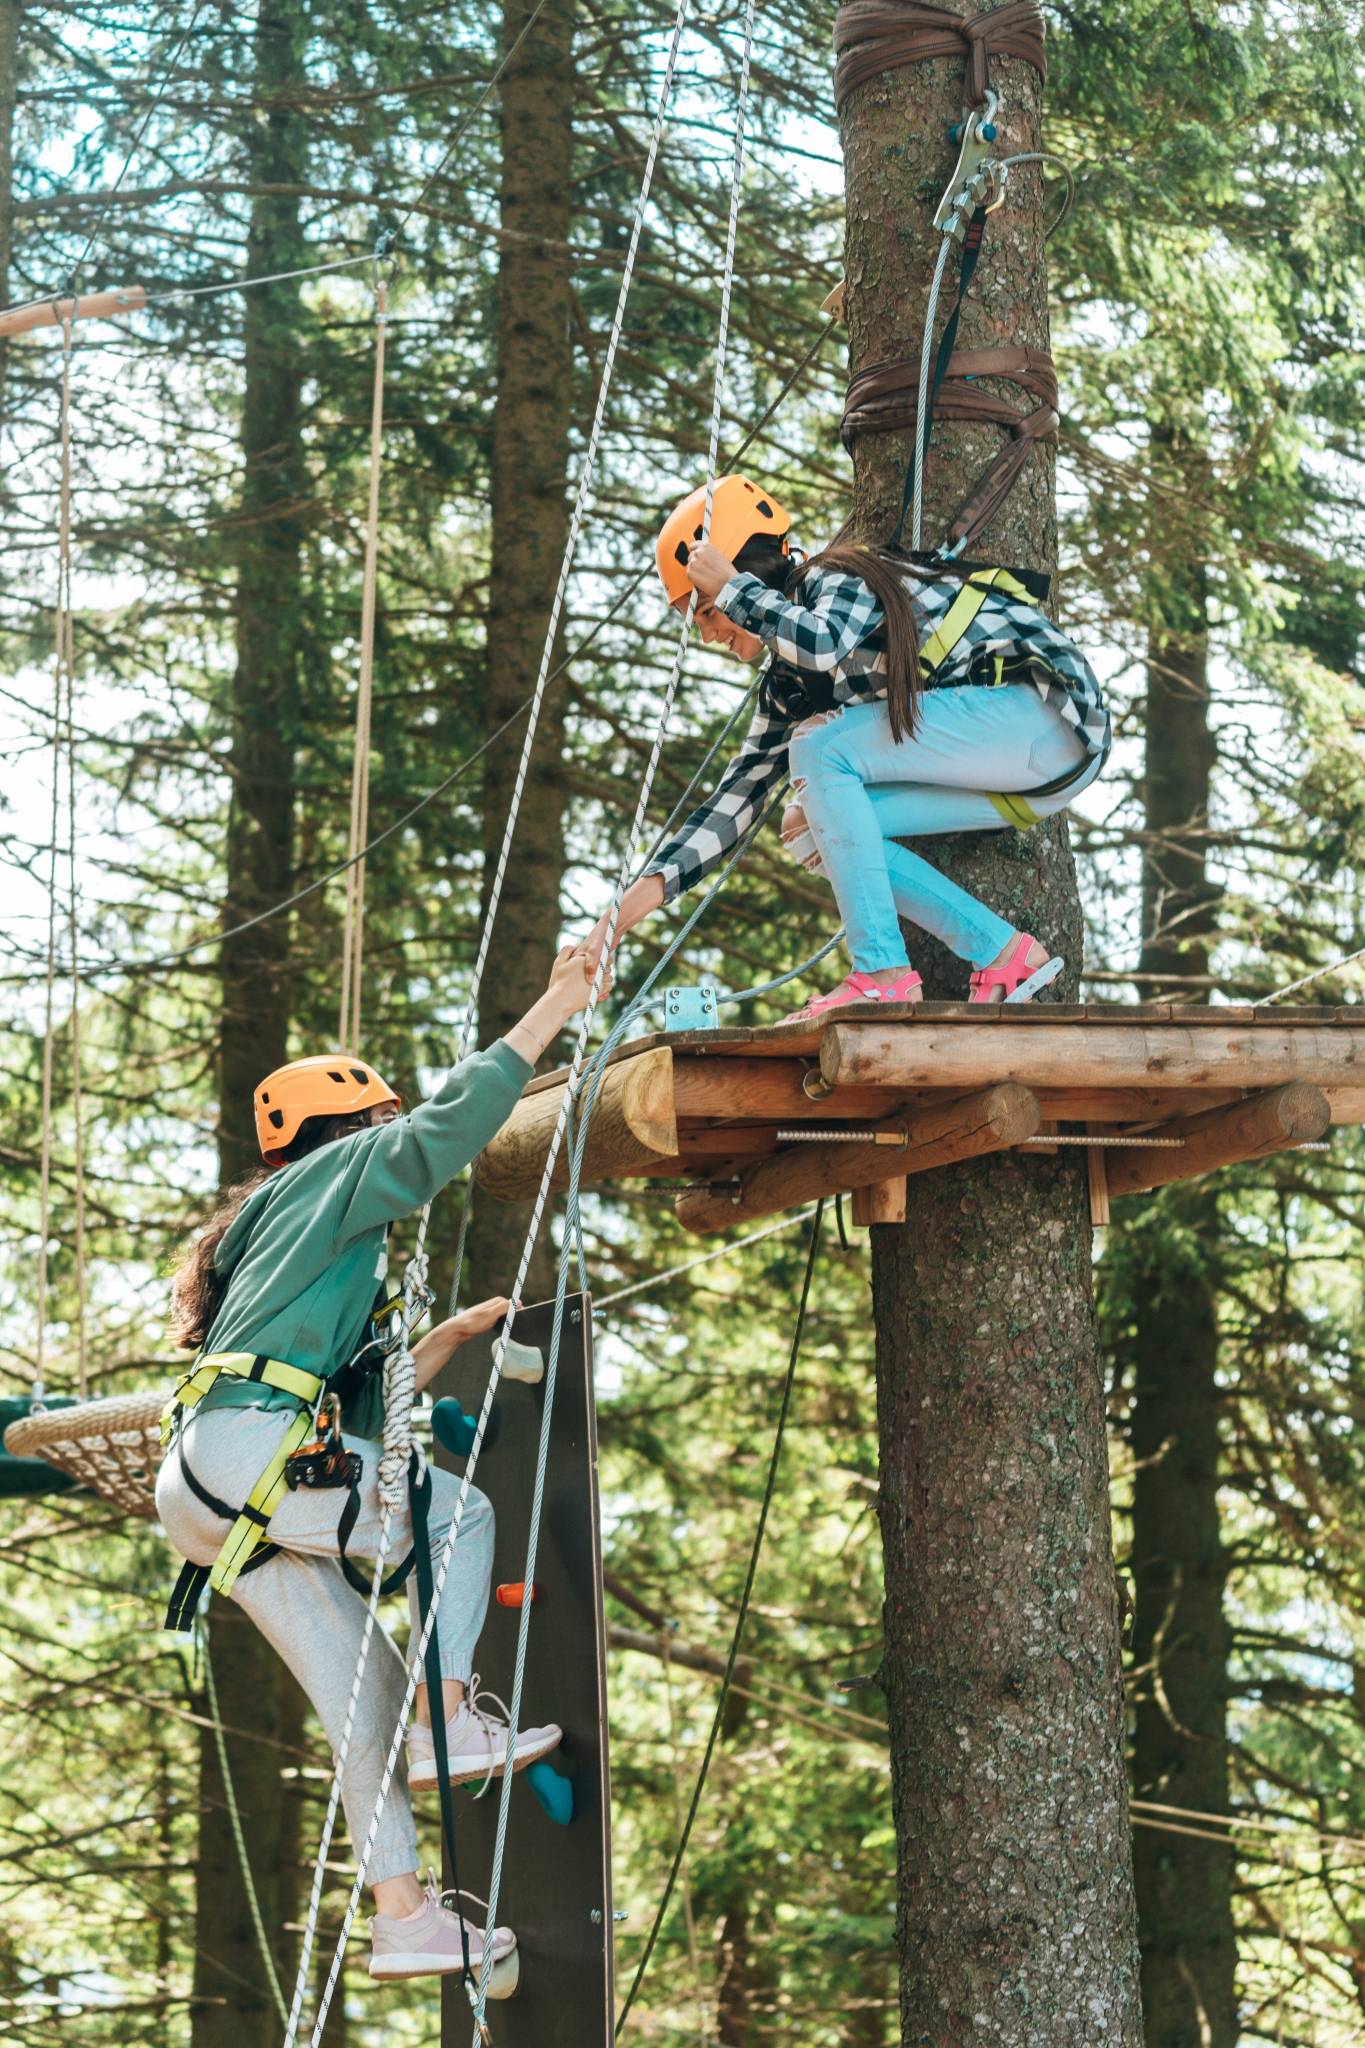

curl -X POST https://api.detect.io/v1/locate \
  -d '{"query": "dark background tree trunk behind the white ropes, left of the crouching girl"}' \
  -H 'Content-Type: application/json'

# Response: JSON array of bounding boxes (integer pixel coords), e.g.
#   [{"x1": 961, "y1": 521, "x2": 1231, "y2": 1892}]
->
[{"x1": 467, "y1": 0, "x2": 573, "y2": 1300}]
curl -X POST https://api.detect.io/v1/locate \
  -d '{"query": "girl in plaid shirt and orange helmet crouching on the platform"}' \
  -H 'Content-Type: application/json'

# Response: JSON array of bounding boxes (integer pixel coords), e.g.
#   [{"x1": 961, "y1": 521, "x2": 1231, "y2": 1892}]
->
[{"x1": 589, "y1": 477, "x2": 1111, "y2": 1018}]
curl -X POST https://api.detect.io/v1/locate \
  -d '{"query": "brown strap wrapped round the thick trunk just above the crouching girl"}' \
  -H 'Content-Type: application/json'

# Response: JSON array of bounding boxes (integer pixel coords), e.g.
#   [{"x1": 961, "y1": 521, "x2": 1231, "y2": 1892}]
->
[{"x1": 839, "y1": 348, "x2": 1058, "y2": 545}]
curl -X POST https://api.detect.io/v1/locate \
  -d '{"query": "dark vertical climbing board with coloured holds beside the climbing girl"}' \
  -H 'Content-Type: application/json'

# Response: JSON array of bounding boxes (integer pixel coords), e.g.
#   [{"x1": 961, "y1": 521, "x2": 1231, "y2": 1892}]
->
[{"x1": 430, "y1": 1294, "x2": 614, "y2": 2048}]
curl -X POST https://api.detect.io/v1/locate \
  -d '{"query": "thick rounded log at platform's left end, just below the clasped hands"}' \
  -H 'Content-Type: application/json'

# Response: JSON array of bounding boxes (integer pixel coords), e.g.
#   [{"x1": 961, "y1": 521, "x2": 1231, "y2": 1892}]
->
[{"x1": 479, "y1": 1044, "x2": 677, "y2": 1202}]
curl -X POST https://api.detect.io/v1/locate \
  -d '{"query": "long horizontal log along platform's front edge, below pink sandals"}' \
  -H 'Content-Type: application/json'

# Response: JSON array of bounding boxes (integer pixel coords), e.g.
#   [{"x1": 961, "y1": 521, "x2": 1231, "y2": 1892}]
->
[{"x1": 821, "y1": 1022, "x2": 1365, "y2": 1090}]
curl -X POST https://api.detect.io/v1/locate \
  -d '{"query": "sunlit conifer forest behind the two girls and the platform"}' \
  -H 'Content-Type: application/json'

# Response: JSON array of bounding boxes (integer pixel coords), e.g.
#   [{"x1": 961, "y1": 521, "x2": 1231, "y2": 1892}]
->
[{"x1": 0, "y1": 0, "x2": 1365, "y2": 2048}]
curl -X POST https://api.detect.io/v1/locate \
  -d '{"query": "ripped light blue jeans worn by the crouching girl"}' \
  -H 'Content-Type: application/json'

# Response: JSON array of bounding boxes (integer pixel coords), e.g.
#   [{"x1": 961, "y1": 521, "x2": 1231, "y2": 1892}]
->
[{"x1": 782, "y1": 682, "x2": 1099, "y2": 975}]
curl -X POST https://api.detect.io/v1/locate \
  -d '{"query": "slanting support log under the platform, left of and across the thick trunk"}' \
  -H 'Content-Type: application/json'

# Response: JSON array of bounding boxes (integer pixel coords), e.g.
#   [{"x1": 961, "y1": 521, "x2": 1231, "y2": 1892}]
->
[{"x1": 675, "y1": 1081, "x2": 1038, "y2": 1237}]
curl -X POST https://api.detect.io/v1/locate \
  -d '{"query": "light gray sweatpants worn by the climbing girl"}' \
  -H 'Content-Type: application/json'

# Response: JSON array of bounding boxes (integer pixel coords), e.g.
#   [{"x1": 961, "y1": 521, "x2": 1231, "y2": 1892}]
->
[{"x1": 156, "y1": 1409, "x2": 493, "y2": 1884}]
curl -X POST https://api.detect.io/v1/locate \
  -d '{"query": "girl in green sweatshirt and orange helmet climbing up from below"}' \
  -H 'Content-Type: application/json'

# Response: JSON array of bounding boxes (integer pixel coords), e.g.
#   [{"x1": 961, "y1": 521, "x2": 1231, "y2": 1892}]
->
[{"x1": 156, "y1": 946, "x2": 591, "y2": 1995}]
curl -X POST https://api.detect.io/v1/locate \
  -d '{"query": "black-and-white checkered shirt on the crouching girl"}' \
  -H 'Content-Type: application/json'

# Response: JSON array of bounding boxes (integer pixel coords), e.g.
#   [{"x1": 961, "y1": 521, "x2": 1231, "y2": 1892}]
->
[{"x1": 645, "y1": 569, "x2": 1111, "y2": 903}]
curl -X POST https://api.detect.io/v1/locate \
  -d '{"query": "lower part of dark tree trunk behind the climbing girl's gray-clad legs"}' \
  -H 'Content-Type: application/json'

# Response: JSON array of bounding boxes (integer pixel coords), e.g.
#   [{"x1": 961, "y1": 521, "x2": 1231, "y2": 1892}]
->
[{"x1": 190, "y1": 1593, "x2": 305, "y2": 2048}]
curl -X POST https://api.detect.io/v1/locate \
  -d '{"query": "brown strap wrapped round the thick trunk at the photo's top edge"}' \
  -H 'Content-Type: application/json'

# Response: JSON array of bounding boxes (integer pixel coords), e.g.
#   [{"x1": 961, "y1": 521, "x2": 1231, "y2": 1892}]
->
[{"x1": 835, "y1": 0, "x2": 1048, "y2": 106}]
